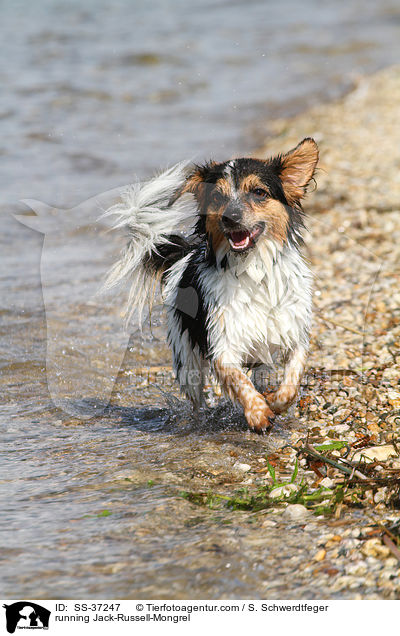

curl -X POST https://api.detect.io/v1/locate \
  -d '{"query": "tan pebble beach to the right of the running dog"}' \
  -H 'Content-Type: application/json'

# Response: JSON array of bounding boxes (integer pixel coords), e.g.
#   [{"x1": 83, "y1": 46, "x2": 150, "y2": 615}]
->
[{"x1": 247, "y1": 67, "x2": 400, "y2": 598}]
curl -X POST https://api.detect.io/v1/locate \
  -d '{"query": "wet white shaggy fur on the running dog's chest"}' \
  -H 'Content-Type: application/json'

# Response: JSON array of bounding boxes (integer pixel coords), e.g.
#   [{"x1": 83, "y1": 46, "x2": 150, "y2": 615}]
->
[{"x1": 201, "y1": 241, "x2": 312, "y2": 364}]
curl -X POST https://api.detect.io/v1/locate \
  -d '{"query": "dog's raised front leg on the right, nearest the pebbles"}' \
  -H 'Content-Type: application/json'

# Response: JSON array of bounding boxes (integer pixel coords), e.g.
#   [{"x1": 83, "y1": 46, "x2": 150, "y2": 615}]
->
[{"x1": 263, "y1": 345, "x2": 307, "y2": 413}]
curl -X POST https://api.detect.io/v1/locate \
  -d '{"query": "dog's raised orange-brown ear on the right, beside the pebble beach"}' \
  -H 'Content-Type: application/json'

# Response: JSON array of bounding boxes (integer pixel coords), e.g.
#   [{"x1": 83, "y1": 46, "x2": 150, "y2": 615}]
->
[{"x1": 279, "y1": 137, "x2": 318, "y2": 205}]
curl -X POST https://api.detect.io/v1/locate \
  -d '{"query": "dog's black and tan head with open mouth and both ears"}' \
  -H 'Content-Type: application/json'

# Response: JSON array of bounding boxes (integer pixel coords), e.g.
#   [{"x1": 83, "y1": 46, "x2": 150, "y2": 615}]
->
[{"x1": 175, "y1": 138, "x2": 318, "y2": 253}]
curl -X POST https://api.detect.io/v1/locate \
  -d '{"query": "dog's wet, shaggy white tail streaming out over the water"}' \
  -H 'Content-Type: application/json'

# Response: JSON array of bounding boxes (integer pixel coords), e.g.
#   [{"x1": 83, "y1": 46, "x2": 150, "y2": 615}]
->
[{"x1": 104, "y1": 162, "x2": 198, "y2": 323}]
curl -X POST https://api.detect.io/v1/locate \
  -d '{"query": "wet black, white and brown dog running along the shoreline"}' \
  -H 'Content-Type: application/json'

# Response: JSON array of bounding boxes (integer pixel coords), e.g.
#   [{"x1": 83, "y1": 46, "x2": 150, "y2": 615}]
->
[{"x1": 107, "y1": 138, "x2": 318, "y2": 433}]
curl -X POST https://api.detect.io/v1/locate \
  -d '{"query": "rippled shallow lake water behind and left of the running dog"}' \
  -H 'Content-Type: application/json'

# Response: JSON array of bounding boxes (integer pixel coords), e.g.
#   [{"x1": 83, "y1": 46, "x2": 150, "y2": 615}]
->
[{"x1": 0, "y1": 0, "x2": 400, "y2": 598}]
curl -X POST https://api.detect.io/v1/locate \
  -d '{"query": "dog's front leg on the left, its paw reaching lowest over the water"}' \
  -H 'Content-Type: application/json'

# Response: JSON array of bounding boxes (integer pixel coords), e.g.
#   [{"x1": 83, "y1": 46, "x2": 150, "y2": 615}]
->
[{"x1": 214, "y1": 360, "x2": 275, "y2": 433}]
